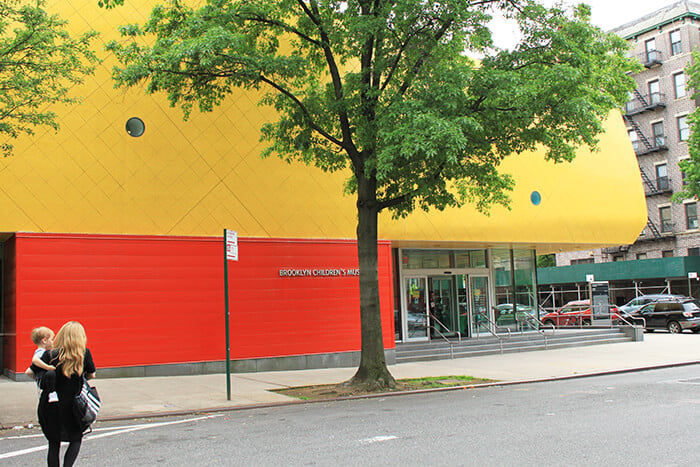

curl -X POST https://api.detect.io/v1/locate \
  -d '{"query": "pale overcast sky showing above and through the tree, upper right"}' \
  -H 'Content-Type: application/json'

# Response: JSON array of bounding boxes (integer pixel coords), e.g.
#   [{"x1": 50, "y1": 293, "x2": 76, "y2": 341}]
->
[{"x1": 492, "y1": 0, "x2": 680, "y2": 47}]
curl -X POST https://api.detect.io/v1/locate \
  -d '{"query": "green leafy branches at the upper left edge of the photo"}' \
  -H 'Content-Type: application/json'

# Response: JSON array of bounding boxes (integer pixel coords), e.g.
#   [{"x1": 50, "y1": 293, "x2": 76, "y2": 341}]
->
[{"x1": 0, "y1": 0, "x2": 97, "y2": 156}]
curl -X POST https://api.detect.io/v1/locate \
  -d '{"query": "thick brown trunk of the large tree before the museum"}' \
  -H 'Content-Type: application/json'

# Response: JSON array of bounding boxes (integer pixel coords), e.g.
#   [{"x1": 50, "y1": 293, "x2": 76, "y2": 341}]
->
[{"x1": 348, "y1": 179, "x2": 395, "y2": 390}]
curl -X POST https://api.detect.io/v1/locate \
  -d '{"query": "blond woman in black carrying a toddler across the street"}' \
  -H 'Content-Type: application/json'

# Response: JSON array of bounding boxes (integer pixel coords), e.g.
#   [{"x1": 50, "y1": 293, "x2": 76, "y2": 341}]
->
[{"x1": 38, "y1": 321, "x2": 95, "y2": 467}]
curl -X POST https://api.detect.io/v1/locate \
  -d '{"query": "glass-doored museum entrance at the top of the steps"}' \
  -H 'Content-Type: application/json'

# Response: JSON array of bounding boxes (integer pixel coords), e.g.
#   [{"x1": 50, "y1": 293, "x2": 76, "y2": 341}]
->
[{"x1": 395, "y1": 249, "x2": 539, "y2": 342}]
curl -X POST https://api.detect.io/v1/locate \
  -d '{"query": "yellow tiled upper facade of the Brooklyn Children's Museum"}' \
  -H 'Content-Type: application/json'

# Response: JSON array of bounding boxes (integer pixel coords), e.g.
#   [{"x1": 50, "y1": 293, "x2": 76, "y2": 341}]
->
[{"x1": 0, "y1": 0, "x2": 647, "y2": 371}]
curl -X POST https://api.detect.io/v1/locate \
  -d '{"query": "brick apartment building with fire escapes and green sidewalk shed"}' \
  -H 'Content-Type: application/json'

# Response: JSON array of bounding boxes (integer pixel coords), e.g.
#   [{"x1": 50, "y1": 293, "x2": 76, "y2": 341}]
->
[{"x1": 540, "y1": 1, "x2": 700, "y2": 303}]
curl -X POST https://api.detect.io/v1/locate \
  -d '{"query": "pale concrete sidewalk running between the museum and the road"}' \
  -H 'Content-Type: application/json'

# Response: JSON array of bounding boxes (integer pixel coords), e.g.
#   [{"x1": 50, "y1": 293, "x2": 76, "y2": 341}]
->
[{"x1": 0, "y1": 333, "x2": 700, "y2": 428}]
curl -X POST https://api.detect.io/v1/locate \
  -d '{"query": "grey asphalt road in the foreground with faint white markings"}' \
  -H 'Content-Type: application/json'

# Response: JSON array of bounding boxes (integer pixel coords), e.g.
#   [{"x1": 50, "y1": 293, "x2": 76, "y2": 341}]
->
[{"x1": 0, "y1": 365, "x2": 700, "y2": 466}]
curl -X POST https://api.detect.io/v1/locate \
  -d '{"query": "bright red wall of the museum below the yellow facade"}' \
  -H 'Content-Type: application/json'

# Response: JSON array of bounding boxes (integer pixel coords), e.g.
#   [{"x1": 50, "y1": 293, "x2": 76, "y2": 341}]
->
[{"x1": 9, "y1": 233, "x2": 394, "y2": 371}]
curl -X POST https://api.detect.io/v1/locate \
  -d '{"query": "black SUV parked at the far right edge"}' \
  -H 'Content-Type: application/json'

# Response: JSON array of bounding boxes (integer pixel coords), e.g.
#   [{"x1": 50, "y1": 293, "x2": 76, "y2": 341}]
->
[{"x1": 632, "y1": 298, "x2": 700, "y2": 334}]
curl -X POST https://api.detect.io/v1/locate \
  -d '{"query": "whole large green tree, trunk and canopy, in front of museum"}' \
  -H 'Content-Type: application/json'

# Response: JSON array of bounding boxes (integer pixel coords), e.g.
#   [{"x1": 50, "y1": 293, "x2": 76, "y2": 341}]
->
[{"x1": 102, "y1": 0, "x2": 635, "y2": 385}]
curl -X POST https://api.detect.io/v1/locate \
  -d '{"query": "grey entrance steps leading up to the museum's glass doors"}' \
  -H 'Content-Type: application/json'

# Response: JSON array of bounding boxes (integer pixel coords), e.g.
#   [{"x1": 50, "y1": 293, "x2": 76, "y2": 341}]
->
[{"x1": 396, "y1": 328, "x2": 635, "y2": 363}]
